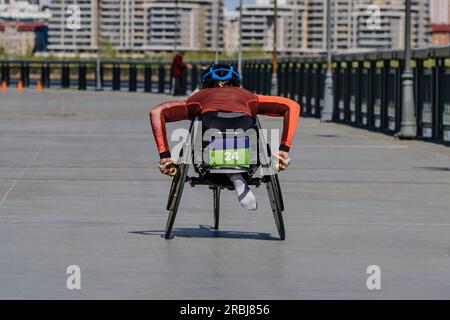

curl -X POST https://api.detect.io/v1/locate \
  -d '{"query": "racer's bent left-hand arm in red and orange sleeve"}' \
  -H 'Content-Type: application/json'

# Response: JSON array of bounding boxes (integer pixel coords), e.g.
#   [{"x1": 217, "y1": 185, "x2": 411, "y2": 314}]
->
[{"x1": 150, "y1": 101, "x2": 191, "y2": 159}]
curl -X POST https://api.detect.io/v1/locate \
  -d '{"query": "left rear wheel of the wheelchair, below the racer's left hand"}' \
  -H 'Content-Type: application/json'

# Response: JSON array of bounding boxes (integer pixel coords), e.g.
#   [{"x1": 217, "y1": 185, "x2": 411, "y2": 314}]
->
[{"x1": 165, "y1": 163, "x2": 189, "y2": 239}]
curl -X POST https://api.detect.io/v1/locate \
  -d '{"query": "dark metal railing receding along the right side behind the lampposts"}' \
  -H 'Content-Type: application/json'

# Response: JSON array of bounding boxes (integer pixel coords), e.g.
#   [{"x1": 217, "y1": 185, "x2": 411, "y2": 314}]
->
[{"x1": 243, "y1": 47, "x2": 450, "y2": 144}]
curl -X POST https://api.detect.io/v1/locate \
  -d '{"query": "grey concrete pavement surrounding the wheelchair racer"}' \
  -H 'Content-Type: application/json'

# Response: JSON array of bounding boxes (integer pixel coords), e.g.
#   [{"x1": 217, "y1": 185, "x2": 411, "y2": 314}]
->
[{"x1": 0, "y1": 90, "x2": 450, "y2": 299}]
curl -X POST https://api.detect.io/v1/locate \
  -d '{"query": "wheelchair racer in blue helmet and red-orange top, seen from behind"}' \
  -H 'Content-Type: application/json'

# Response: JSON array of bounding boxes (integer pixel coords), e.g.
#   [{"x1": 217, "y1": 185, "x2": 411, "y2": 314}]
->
[{"x1": 150, "y1": 64, "x2": 300, "y2": 210}]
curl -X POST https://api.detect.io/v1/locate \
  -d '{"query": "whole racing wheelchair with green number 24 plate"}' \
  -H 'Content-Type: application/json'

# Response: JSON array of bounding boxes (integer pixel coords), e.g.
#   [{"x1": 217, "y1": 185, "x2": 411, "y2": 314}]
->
[{"x1": 165, "y1": 112, "x2": 285, "y2": 240}]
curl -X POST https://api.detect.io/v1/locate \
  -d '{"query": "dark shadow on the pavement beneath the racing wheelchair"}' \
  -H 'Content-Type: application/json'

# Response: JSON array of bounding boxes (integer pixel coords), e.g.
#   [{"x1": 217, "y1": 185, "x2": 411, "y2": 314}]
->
[{"x1": 129, "y1": 225, "x2": 280, "y2": 240}]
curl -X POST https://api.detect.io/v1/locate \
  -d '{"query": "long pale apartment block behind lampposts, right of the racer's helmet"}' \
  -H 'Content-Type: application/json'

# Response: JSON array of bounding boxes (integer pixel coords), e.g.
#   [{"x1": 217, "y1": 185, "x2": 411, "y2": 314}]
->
[{"x1": 236, "y1": 0, "x2": 430, "y2": 54}]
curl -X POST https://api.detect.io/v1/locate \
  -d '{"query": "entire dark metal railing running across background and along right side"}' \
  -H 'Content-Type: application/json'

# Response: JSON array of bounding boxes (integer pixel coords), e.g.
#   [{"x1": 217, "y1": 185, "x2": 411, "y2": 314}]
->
[{"x1": 0, "y1": 47, "x2": 450, "y2": 144}]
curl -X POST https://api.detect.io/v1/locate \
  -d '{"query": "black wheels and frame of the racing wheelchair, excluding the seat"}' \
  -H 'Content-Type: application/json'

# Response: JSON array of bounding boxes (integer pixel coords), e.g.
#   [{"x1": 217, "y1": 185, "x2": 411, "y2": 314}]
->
[{"x1": 165, "y1": 118, "x2": 286, "y2": 240}]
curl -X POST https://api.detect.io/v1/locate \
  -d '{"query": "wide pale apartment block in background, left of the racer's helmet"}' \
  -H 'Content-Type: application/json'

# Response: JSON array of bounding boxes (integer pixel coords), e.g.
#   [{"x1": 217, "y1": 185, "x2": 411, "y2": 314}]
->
[{"x1": 49, "y1": 0, "x2": 223, "y2": 53}]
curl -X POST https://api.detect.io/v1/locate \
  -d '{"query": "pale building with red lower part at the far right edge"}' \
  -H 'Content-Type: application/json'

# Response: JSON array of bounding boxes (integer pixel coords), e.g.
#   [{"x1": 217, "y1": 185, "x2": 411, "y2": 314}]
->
[{"x1": 430, "y1": 0, "x2": 450, "y2": 46}]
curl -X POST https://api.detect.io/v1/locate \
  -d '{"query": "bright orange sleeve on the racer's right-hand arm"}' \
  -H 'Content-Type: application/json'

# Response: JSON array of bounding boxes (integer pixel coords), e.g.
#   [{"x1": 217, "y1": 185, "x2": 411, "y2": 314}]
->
[{"x1": 257, "y1": 95, "x2": 300, "y2": 152}]
